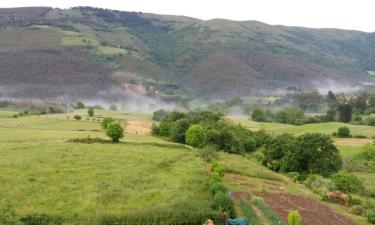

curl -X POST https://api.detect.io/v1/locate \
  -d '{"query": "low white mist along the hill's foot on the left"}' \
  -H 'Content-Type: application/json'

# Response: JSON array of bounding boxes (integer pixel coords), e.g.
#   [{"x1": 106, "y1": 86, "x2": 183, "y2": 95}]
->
[{"x1": 0, "y1": 85, "x2": 177, "y2": 112}]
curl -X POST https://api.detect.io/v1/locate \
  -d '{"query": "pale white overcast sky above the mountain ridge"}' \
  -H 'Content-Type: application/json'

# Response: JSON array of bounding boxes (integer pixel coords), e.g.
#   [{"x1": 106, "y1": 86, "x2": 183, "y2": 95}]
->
[{"x1": 0, "y1": 0, "x2": 375, "y2": 32}]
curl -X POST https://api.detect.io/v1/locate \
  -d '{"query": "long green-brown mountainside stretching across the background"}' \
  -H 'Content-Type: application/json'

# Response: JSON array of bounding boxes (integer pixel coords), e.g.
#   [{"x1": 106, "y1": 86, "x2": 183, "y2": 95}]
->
[{"x1": 0, "y1": 7, "x2": 375, "y2": 100}]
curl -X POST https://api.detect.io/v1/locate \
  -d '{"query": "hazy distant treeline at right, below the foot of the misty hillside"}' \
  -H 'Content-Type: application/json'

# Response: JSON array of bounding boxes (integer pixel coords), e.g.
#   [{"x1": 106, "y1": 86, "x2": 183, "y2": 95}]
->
[{"x1": 251, "y1": 91, "x2": 375, "y2": 126}]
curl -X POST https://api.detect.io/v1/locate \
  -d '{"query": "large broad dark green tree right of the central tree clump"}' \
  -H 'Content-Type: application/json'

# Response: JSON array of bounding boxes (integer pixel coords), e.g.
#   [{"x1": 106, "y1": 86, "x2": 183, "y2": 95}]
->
[{"x1": 263, "y1": 133, "x2": 342, "y2": 176}]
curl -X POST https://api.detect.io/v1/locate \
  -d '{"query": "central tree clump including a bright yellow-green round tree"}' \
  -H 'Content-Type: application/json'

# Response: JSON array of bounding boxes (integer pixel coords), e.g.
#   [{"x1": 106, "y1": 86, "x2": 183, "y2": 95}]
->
[{"x1": 152, "y1": 110, "x2": 269, "y2": 153}]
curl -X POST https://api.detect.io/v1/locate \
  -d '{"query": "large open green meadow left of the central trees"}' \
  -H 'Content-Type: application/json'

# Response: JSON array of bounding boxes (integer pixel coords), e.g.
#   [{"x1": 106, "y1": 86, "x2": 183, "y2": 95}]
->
[{"x1": 0, "y1": 110, "x2": 214, "y2": 223}]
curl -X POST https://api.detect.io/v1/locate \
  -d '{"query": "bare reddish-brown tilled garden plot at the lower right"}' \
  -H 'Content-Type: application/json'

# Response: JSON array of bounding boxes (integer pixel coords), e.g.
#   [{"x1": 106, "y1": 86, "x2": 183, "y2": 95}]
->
[{"x1": 264, "y1": 193, "x2": 356, "y2": 225}]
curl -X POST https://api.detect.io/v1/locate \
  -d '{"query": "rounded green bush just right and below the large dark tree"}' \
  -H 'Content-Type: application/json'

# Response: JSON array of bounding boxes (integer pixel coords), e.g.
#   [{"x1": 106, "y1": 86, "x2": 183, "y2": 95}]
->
[{"x1": 332, "y1": 171, "x2": 364, "y2": 193}]
